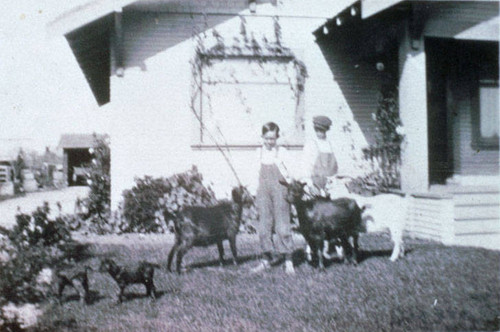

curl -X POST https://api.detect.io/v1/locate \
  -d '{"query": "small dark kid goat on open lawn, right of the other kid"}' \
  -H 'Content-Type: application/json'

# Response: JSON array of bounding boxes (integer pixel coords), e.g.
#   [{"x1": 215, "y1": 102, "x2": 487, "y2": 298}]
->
[{"x1": 99, "y1": 258, "x2": 160, "y2": 303}]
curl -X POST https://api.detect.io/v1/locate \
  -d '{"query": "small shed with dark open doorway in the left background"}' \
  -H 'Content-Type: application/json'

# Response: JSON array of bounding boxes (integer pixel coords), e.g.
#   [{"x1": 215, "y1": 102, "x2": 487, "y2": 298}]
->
[{"x1": 58, "y1": 134, "x2": 104, "y2": 186}]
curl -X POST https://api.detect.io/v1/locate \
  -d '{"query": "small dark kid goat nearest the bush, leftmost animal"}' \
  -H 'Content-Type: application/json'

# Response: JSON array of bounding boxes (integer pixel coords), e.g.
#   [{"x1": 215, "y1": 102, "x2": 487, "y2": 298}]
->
[{"x1": 55, "y1": 266, "x2": 92, "y2": 303}]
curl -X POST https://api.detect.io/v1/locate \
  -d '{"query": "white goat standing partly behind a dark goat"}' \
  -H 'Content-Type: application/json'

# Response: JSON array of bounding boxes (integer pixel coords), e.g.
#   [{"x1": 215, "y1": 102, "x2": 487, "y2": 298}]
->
[{"x1": 330, "y1": 176, "x2": 408, "y2": 262}]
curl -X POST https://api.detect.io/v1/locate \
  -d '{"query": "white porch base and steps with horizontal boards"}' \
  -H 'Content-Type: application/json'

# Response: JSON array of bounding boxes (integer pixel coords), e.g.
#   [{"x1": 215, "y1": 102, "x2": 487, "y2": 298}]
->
[{"x1": 407, "y1": 182, "x2": 500, "y2": 250}]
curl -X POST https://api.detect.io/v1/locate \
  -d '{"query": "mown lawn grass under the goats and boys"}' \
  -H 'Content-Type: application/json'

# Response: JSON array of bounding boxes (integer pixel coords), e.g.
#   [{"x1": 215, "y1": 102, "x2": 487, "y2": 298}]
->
[{"x1": 41, "y1": 235, "x2": 500, "y2": 331}]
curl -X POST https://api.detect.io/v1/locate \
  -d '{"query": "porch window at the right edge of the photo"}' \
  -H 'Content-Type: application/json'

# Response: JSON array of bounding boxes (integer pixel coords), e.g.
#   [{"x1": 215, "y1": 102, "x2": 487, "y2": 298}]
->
[{"x1": 472, "y1": 80, "x2": 500, "y2": 149}]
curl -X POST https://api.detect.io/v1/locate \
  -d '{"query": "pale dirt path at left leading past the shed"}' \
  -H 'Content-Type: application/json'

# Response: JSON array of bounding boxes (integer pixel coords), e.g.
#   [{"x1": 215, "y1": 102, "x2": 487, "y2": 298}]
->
[{"x1": 0, "y1": 187, "x2": 89, "y2": 228}]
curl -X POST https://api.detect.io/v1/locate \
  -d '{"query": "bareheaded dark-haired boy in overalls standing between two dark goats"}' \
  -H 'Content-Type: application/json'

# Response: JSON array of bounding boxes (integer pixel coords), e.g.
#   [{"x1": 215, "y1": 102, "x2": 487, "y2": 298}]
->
[{"x1": 252, "y1": 122, "x2": 295, "y2": 274}]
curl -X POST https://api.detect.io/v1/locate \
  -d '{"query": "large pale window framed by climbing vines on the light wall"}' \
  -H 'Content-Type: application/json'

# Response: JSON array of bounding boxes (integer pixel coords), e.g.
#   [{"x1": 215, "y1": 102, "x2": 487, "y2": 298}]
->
[{"x1": 193, "y1": 57, "x2": 303, "y2": 147}]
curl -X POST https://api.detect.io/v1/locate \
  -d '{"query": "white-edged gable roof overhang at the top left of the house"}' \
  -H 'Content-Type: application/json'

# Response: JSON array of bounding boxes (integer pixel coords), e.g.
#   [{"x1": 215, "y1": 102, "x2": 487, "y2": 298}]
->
[{"x1": 46, "y1": 0, "x2": 352, "y2": 106}]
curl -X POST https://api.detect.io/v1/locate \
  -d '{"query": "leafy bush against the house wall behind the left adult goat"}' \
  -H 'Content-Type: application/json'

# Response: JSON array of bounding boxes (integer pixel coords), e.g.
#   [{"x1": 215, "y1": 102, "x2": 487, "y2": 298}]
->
[{"x1": 122, "y1": 166, "x2": 217, "y2": 232}]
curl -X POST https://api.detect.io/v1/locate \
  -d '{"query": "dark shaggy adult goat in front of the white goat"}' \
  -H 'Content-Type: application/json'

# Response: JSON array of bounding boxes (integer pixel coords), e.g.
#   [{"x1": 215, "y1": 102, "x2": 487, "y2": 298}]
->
[{"x1": 280, "y1": 180, "x2": 364, "y2": 269}]
